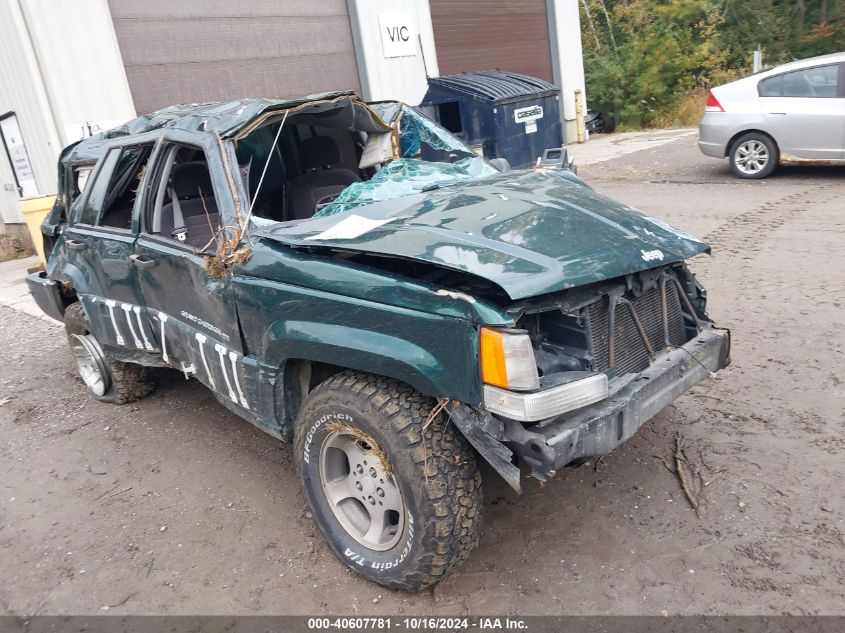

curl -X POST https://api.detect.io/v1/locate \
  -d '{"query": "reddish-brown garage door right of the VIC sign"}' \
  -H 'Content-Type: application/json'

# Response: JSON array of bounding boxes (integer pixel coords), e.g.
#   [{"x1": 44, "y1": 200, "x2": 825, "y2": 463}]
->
[{"x1": 431, "y1": 0, "x2": 553, "y2": 82}]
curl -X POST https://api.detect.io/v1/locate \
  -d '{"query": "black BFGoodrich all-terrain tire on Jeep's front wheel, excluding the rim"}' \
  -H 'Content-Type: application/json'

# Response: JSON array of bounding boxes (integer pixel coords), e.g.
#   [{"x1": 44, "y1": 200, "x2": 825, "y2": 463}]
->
[{"x1": 294, "y1": 371, "x2": 482, "y2": 591}]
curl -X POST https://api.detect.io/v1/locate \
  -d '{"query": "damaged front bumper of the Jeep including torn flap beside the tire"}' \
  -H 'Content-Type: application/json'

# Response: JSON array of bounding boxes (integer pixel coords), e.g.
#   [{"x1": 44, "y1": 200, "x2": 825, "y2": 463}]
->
[{"x1": 448, "y1": 327, "x2": 730, "y2": 492}]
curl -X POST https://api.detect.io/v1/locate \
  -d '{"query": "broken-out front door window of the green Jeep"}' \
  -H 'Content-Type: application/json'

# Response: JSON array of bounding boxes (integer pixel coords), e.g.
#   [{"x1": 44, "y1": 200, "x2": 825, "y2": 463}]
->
[{"x1": 145, "y1": 145, "x2": 220, "y2": 252}]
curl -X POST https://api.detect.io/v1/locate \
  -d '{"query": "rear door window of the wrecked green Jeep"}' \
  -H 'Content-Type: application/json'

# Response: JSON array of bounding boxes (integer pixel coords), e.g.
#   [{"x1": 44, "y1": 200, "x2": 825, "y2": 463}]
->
[{"x1": 77, "y1": 143, "x2": 153, "y2": 231}]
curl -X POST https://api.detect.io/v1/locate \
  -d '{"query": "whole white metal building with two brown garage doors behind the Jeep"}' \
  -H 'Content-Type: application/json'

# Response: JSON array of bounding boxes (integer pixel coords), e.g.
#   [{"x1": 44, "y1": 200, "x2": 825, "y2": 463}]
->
[{"x1": 0, "y1": 0, "x2": 584, "y2": 232}]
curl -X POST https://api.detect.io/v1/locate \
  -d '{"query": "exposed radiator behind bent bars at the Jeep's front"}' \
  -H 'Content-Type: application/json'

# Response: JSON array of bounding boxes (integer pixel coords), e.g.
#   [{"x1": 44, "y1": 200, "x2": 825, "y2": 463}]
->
[{"x1": 586, "y1": 280, "x2": 687, "y2": 376}]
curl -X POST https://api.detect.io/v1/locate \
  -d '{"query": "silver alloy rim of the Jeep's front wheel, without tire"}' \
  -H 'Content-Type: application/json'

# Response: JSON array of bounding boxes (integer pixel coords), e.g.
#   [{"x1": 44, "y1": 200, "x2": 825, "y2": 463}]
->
[{"x1": 320, "y1": 432, "x2": 405, "y2": 552}]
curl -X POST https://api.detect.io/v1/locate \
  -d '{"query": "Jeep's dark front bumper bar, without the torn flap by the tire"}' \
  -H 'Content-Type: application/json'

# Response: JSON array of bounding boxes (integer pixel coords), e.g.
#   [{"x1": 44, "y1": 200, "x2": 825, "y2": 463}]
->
[{"x1": 504, "y1": 328, "x2": 730, "y2": 480}]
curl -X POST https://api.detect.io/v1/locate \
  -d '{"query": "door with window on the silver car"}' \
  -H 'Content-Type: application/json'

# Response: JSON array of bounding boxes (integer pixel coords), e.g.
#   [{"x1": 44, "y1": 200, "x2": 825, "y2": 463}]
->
[{"x1": 758, "y1": 64, "x2": 845, "y2": 160}]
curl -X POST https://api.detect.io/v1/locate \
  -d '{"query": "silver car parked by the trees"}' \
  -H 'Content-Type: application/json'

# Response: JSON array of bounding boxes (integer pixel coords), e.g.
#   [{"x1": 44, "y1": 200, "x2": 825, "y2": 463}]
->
[{"x1": 698, "y1": 52, "x2": 845, "y2": 178}]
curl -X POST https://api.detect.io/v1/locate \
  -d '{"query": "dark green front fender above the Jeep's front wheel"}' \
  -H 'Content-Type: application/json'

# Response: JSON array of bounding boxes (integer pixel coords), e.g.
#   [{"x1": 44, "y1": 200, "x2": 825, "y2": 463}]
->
[{"x1": 234, "y1": 277, "x2": 481, "y2": 404}]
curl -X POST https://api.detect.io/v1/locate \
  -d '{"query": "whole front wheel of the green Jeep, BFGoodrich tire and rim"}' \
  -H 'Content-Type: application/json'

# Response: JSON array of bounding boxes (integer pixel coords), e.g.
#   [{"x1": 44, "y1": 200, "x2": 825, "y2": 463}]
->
[{"x1": 294, "y1": 372, "x2": 482, "y2": 591}]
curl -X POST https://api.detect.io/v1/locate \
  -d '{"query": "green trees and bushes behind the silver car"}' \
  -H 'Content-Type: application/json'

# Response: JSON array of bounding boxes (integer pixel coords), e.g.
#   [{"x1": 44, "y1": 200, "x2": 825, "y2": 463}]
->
[{"x1": 579, "y1": 0, "x2": 845, "y2": 127}]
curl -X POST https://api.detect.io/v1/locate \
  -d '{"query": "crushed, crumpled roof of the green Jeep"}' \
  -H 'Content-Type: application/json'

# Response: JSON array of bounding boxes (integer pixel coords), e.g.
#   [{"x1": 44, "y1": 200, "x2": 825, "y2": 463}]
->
[{"x1": 61, "y1": 91, "x2": 375, "y2": 163}]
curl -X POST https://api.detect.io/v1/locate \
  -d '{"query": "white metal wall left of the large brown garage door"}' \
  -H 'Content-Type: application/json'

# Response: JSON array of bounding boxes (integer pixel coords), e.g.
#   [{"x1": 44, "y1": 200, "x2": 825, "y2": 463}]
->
[{"x1": 0, "y1": 0, "x2": 135, "y2": 227}]
